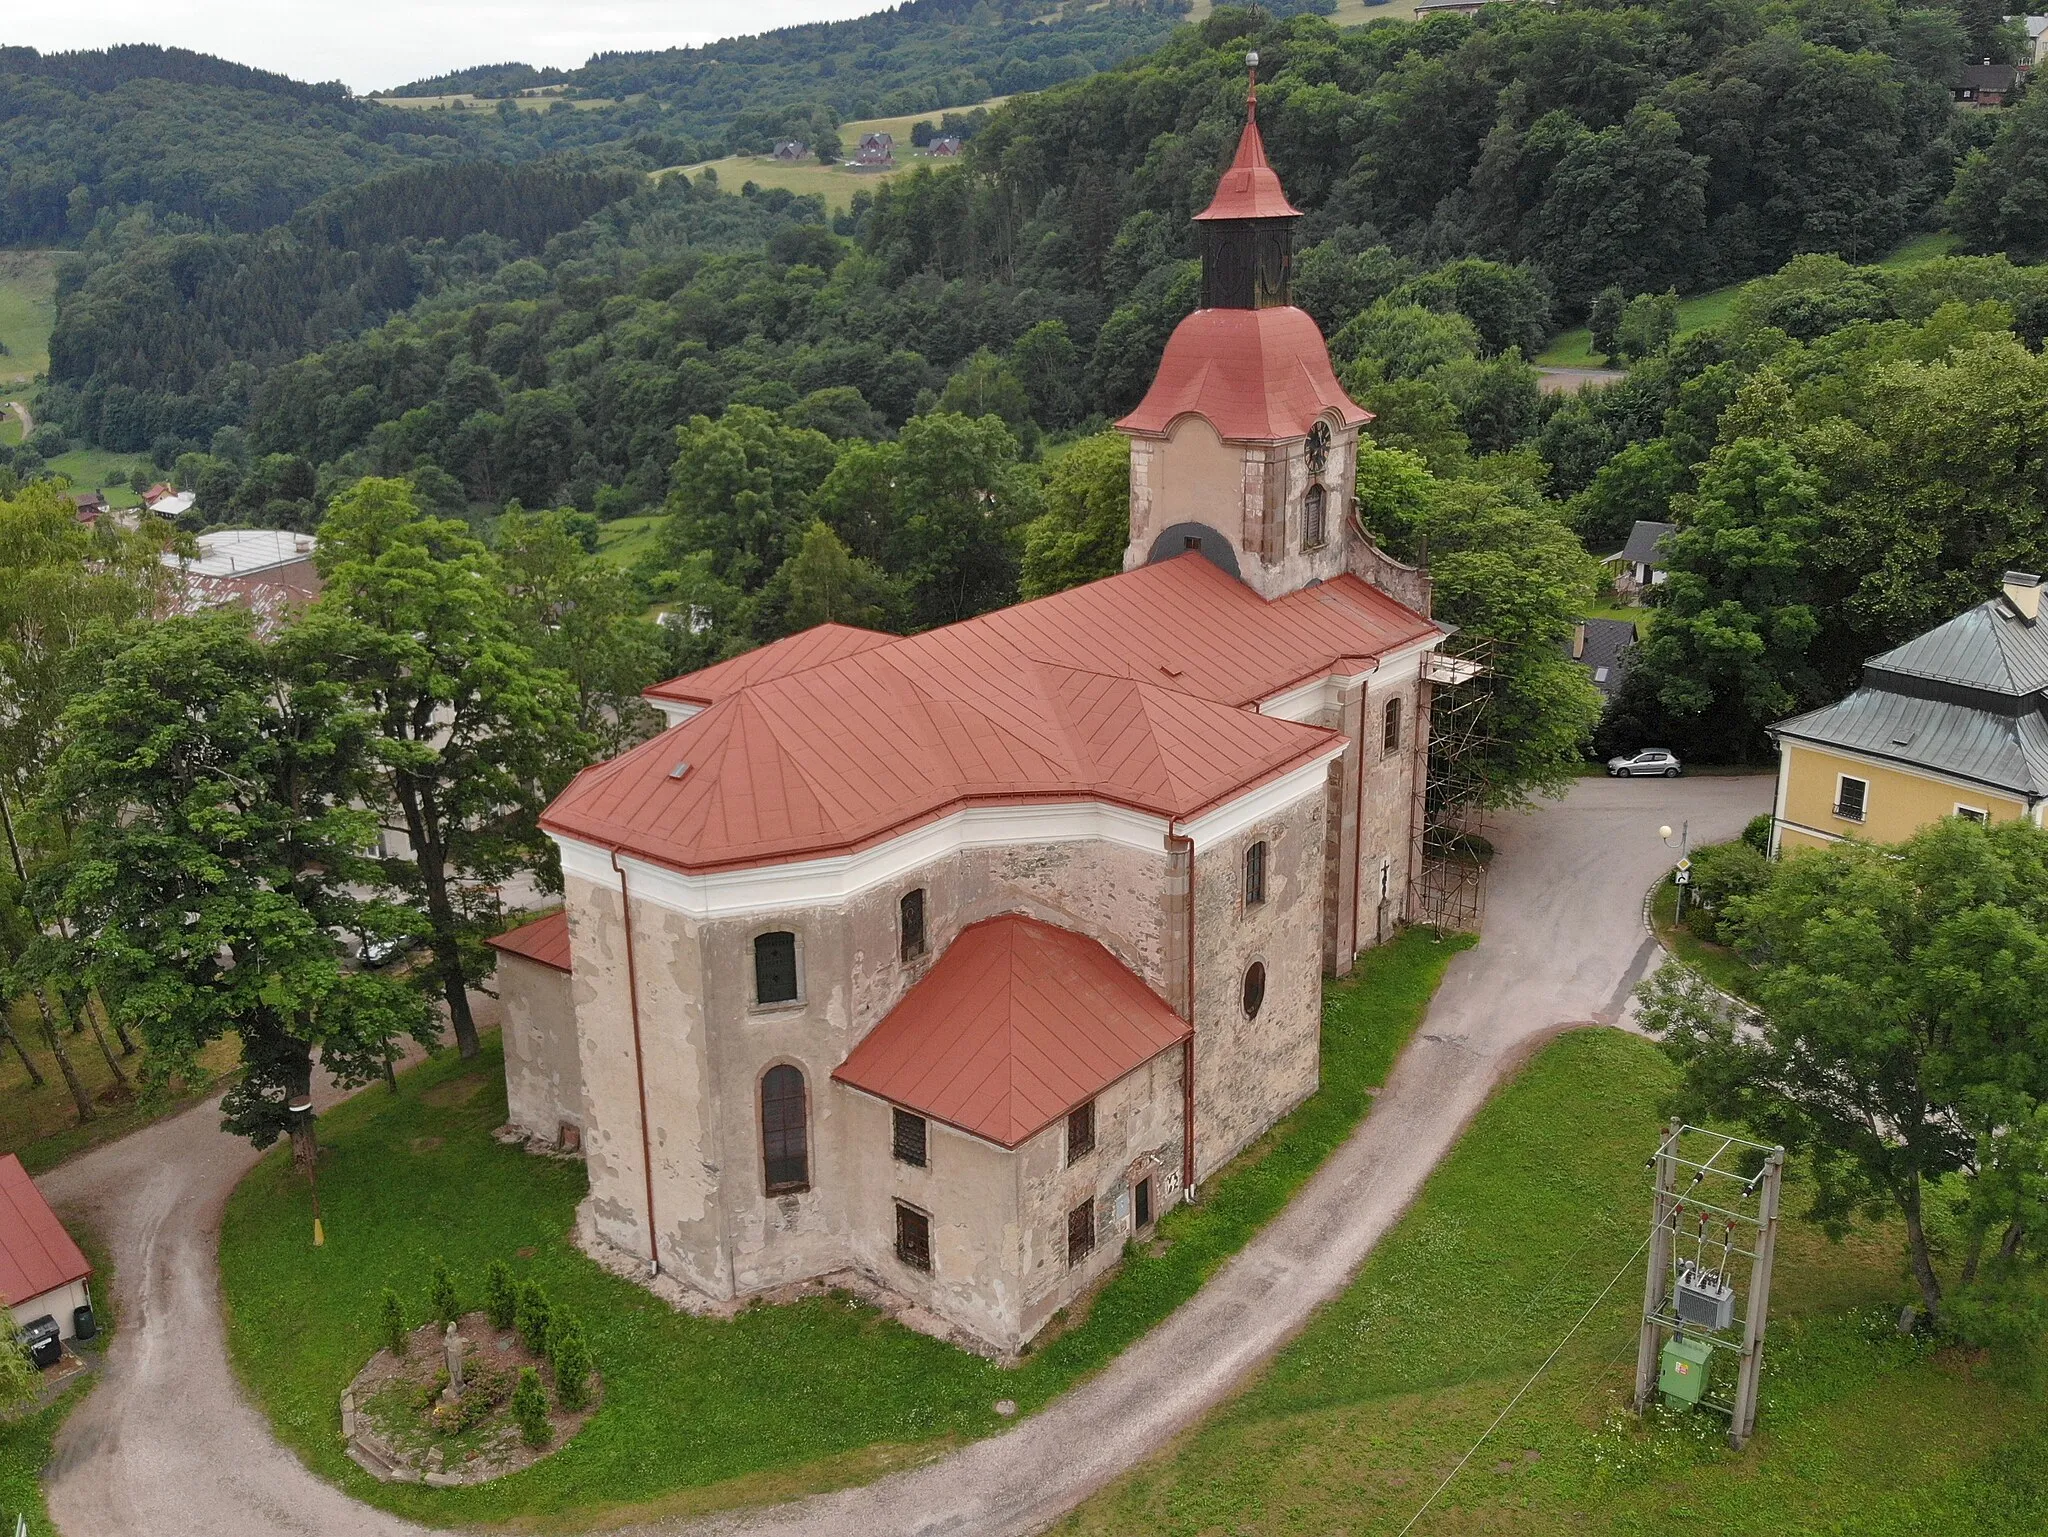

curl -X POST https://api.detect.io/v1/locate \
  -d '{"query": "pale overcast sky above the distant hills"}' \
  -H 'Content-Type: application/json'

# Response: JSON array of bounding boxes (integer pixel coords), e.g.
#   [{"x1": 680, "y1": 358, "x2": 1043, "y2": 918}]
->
[{"x1": 12, "y1": 0, "x2": 889, "y2": 94}]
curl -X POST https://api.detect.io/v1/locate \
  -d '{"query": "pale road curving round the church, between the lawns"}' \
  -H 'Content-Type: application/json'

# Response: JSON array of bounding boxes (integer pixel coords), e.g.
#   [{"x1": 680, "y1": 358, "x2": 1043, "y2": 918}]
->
[{"x1": 45, "y1": 779, "x2": 1772, "y2": 1537}]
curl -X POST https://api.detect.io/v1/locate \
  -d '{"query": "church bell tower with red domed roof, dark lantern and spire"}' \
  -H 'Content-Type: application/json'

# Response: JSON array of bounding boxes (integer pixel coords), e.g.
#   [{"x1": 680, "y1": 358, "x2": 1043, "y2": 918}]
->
[{"x1": 1116, "y1": 53, "x2": 1372, "y2": 598}]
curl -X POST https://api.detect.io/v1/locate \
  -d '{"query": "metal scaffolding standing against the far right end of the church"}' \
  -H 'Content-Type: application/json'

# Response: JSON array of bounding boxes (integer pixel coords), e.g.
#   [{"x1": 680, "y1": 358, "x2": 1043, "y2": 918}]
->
[{"x1": 1409, "y1": 635, "x2": 1495, "y2": 932}]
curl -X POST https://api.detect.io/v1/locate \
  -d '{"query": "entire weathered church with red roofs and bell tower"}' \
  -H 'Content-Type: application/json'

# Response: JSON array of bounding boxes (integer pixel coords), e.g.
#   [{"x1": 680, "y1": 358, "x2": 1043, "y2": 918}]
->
[{"x1": 498, "y1": 66, "x2": 1462, "y2": 1353}]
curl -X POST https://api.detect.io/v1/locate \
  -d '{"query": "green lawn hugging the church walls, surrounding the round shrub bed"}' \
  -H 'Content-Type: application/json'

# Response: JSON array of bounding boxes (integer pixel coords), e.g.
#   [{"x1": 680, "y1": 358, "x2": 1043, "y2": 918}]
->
[{"x1": 221, "y1": 932, "x2": 1462, "y2": 1529}]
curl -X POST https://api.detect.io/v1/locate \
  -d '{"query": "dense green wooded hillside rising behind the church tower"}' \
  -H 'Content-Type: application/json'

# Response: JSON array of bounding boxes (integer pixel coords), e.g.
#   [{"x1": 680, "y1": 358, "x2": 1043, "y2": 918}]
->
[{"x1": 12, "y1": 0, "x2": 2048, "y2": 793}]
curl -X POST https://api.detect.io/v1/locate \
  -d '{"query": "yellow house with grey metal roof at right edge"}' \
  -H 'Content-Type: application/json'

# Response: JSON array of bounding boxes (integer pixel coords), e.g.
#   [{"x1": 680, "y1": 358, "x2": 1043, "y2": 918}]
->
[{"x1": 1772, "y1": 572, "x2": 2048, "y2": 855}]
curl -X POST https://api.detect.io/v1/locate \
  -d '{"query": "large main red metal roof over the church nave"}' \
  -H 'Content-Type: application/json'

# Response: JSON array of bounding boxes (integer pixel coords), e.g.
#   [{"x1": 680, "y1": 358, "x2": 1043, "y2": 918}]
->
[{"x1": 543, "y1": 555, "x2": 1438, "y2": 871}]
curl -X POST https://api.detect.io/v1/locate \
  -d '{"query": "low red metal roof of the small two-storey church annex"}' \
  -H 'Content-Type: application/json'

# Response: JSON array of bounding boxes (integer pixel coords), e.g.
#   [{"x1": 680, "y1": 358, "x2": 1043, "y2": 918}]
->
[{"x1": 831, "y1": 914, "x2": 1188, "y2": 1148}]
